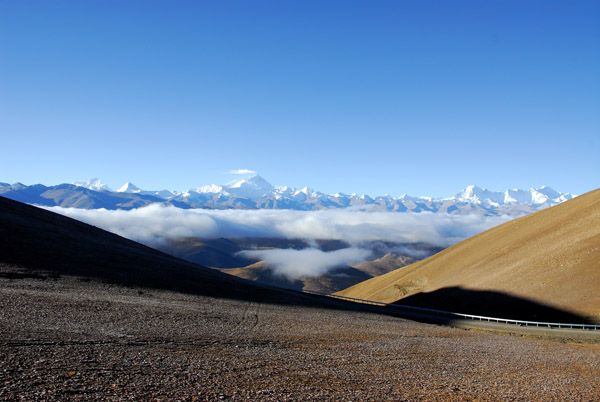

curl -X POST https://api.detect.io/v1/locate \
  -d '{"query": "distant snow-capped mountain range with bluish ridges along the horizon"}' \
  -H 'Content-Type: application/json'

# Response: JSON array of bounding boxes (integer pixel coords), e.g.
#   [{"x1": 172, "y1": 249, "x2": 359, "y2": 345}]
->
[{"x1": 0, "y1": 175, "x2": 575, "y2": 216}]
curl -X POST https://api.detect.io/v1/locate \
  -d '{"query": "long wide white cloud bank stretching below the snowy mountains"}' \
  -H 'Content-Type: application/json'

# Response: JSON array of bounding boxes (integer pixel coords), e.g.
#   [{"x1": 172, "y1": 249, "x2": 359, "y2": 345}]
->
[{"x1": 47, "y1": 204, "x2": 510, "y2": 247}]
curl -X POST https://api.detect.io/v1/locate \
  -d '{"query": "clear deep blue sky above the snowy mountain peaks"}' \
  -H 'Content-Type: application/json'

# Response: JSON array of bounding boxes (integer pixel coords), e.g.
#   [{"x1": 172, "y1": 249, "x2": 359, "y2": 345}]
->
[{"x1": 0, "y1": 0, "x2": 600, "y2": 196}]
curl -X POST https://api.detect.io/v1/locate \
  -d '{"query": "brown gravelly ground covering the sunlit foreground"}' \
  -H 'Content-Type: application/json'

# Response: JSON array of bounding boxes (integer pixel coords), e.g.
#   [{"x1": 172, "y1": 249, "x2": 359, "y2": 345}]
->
[{"x1": 0, "y1": 277, "x2": 600, "y2": 401}]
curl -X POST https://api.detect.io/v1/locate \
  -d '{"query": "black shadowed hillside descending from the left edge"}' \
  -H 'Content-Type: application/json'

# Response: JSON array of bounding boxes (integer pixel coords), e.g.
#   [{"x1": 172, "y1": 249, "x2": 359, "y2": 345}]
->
[{"x1": 0, "y1": 197, "x2": 328, "y2": 303}]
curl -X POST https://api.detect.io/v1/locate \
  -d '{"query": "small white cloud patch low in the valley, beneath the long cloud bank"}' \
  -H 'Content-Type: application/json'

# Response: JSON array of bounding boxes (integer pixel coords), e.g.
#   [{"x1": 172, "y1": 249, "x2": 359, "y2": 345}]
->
[{"x1": 239, "y1": 247, "x2": 371, "y2": 279}]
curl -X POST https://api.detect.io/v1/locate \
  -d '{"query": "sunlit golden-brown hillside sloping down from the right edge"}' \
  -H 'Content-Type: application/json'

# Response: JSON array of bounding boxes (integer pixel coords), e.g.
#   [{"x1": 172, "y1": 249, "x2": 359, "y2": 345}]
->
[{"x1": 338, "y1": 189, "x2": 600, "y2": 321}]
